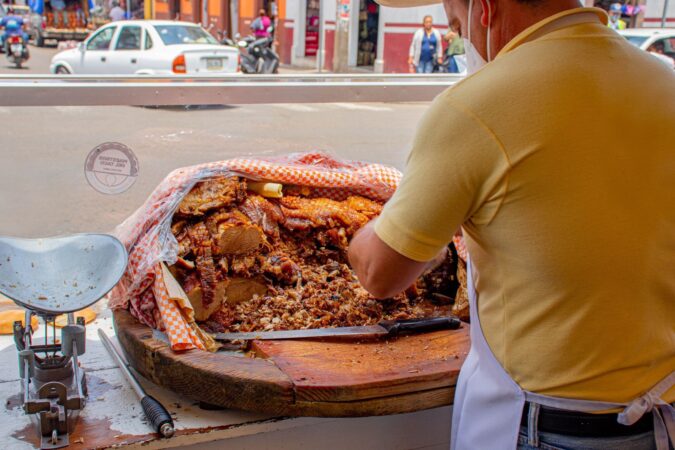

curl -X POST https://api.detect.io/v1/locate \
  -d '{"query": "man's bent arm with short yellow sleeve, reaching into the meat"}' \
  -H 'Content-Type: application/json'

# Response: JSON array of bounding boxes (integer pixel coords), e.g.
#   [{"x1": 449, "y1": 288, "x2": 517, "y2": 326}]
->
[{"x1": 349, "y1": 94, "x2": 508, "y2": 298}]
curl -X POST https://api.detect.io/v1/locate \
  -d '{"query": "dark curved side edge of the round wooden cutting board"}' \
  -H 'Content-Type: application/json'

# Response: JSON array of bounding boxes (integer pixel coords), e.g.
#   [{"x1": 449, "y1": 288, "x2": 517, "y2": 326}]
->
[{"x1": 113, "y1": 310, "x2": 462, "y2": 417}]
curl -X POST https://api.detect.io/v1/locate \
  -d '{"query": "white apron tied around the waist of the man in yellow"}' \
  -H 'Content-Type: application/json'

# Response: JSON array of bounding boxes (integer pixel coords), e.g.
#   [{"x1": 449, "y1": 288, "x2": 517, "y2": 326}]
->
[{"x1": 451, "y1": 261, "x2": 675, "y2": 450}]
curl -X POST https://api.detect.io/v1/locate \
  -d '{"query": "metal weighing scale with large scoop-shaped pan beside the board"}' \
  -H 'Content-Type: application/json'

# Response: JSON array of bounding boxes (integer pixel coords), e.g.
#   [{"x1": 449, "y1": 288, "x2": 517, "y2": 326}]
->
[{"x1": 0, "y1": 234, "x2": 127, "y2": 449}]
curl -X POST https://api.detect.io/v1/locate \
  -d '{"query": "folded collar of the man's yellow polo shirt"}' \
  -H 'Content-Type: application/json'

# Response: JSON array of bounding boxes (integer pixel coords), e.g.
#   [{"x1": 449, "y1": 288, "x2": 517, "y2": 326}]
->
[{"x1": 497, "y1": 8, "x2": 609, "y2": 58}]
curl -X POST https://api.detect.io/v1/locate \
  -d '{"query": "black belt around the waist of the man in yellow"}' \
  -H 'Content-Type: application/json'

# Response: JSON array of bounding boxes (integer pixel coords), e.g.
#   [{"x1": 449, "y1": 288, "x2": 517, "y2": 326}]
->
[{"x1": 520, "y1": 403, "x2": 654, "y2": 437}]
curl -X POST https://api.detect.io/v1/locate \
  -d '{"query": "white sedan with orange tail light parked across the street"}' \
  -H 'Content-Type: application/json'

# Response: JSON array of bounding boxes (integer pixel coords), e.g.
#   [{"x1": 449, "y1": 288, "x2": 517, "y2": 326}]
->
[{"x1": 50, "y1": 20, "x2": 239, "y2": 76}]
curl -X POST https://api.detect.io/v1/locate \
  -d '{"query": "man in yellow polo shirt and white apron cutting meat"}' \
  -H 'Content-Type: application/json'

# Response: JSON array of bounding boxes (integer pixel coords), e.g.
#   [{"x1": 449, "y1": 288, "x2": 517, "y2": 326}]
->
[{"x1": 350, "y1": 0, "x2": 675, "y2": 450}]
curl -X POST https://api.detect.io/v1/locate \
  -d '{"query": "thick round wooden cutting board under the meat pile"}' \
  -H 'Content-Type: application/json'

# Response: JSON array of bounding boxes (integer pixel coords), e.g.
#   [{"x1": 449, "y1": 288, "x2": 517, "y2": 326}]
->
[{"x1": 114, "y1": 311, "x2": 469, "y2": 417}]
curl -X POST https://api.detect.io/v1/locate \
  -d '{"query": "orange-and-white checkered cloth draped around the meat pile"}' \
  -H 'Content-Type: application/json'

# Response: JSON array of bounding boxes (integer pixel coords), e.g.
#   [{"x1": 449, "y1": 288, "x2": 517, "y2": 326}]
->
[{"x1": 109, "y1": 152, "x2": 401, "y2": 350}]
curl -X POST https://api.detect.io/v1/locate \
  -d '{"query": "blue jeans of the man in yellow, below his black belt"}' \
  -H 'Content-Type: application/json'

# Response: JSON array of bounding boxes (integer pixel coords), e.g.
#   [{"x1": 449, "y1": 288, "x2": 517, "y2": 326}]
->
[{"x1": 518, "y1": 427, "x2": 656, "y2": 450}]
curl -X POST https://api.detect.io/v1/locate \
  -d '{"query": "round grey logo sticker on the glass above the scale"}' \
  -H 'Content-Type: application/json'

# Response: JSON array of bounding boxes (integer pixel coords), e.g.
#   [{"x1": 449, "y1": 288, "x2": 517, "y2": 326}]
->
[{"x1": 84, "y1": 142, "x2": 138, "y2": 194}]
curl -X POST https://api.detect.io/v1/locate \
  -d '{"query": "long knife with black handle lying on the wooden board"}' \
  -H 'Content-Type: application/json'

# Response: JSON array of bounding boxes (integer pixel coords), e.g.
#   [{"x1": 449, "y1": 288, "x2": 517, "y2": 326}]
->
[{"x1": 212, "y1": 317, "x2": 461, "y2": 341}]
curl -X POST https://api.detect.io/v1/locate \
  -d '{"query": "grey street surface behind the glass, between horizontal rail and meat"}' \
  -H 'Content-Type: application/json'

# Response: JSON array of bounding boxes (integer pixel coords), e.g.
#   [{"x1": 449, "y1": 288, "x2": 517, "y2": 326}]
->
[{"x1": 0, "y1": 103, "x2": 426, "y2": 237}]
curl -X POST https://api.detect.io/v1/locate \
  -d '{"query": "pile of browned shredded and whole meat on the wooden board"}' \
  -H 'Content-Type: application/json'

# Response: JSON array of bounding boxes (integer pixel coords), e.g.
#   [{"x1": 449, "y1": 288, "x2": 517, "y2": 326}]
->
[{"x1": 171, "y1": 177, "x2": 459, "y2": 331}]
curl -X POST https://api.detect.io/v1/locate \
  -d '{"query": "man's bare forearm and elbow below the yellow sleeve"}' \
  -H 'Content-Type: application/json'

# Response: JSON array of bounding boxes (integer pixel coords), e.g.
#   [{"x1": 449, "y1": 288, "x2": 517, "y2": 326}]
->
[{"x1": 349, "y1": 221, "x2": 438, "y2": 299}]
